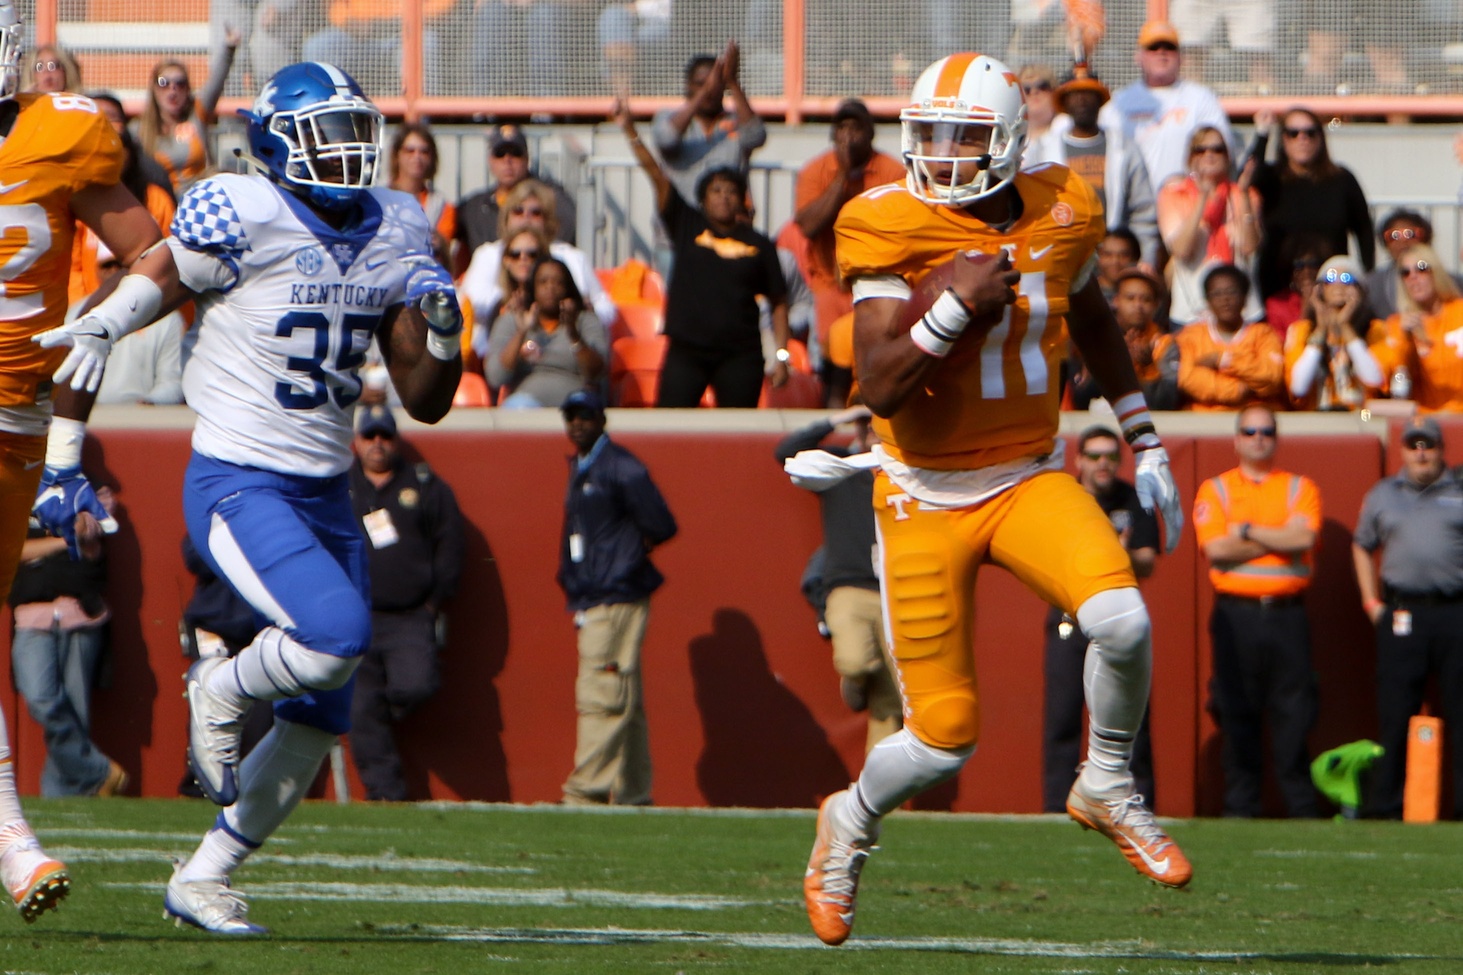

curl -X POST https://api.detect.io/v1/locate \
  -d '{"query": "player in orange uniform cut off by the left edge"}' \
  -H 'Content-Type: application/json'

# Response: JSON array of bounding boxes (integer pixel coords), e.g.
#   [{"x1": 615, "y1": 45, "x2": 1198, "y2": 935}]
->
[{"x1": 0, "y1": 0, "x2": 161, "y2": 921}]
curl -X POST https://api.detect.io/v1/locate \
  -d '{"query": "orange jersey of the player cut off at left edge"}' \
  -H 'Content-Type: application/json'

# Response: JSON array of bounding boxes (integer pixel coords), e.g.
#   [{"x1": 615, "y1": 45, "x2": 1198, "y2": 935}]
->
[{"x1": 0, "y1": 94, "x2": 123, "y2": 407}]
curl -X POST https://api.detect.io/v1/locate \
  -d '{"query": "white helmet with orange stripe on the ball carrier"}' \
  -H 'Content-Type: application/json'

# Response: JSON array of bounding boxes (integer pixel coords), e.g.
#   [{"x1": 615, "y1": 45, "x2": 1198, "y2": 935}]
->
[{"x1": 900, "y1": 53, "x2": 1026, "y2": 206}]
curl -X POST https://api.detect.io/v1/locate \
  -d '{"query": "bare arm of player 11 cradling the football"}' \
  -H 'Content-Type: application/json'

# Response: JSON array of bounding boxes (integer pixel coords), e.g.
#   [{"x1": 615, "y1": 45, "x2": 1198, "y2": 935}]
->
[{"x1": 853, "y1": 253, "x2": 1021, "y2": 417}]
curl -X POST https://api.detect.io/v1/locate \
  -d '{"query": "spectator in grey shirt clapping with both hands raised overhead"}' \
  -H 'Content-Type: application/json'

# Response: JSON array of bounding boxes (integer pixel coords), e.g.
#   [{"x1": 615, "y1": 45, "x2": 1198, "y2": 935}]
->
[{"x1": 651, "y1": 41, "x2": 767, "y2": 206}]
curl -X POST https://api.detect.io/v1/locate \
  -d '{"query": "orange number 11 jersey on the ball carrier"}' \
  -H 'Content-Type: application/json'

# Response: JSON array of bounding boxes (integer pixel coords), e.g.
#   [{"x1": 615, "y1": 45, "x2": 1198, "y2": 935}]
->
[{"x1": 834, "y1": 165, "x2": 1106, "y2": 470}]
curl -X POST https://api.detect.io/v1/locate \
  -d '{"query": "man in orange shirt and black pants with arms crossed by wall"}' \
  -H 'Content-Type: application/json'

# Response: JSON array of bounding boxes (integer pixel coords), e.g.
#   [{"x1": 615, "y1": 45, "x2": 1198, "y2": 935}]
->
[{"x1": 1194, "y1": 406, "x2": 1321, "y2": 817}]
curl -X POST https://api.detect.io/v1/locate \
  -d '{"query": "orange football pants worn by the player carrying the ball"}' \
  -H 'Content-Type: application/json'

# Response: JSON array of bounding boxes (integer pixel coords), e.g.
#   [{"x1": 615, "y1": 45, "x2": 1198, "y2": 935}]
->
[{"x1": 873, "y1": 471, "x2": 1138, "y2": 748}]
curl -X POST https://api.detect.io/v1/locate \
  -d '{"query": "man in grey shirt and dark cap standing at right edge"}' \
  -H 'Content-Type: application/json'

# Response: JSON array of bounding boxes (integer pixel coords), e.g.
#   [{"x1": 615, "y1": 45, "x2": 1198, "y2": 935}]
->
[{"x1": 1352, "y1": 416, "x2": 1463, "y2": 820}]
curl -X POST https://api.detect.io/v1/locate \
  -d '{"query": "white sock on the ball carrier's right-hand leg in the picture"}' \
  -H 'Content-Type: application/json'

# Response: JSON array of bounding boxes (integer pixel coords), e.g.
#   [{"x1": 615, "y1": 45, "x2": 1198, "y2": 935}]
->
[{"x1": 1077, "y1": 589, "x2": 1153, "y2": 792}]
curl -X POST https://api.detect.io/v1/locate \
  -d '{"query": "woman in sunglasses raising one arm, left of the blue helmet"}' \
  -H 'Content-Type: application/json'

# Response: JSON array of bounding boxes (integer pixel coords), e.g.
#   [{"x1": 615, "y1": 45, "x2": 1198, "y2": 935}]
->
[{"x1": 138, "y1": 43, "x2": 238, "y2": 196}]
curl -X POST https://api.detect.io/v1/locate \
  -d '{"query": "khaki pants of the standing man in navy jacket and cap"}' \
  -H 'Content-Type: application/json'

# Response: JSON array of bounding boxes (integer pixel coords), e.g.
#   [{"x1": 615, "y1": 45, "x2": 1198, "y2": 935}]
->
[{"x1": 563, "y1": 599, "x2": 650, "y2": 805}]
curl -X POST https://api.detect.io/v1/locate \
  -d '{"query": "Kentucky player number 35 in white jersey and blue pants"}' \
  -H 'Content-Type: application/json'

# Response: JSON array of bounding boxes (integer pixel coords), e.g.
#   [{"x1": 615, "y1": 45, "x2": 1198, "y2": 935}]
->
[{"x1": 38, "y1": 63, "x2": 462, "y2": 934}]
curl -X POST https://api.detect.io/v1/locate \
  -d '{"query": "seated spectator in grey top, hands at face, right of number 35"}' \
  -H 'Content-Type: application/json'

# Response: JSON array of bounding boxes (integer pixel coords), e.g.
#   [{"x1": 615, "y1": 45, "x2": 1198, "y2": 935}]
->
[{"x1": 484, "y1": 258, "x2": 610, "y2": 410}]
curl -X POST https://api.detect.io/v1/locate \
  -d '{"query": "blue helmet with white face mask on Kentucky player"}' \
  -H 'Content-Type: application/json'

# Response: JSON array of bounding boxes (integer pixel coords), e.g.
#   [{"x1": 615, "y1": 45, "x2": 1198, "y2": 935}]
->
[{"x1": 240, "y1": 61, "x2": 380, "y2": 211}]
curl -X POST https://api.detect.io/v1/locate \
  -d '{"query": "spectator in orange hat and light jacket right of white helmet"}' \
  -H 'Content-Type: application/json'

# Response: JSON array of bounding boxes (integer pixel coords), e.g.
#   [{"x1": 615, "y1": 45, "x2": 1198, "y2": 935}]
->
[{"x1": 1049, "y1": 64, "x2": 1159, "y2": 269}]
